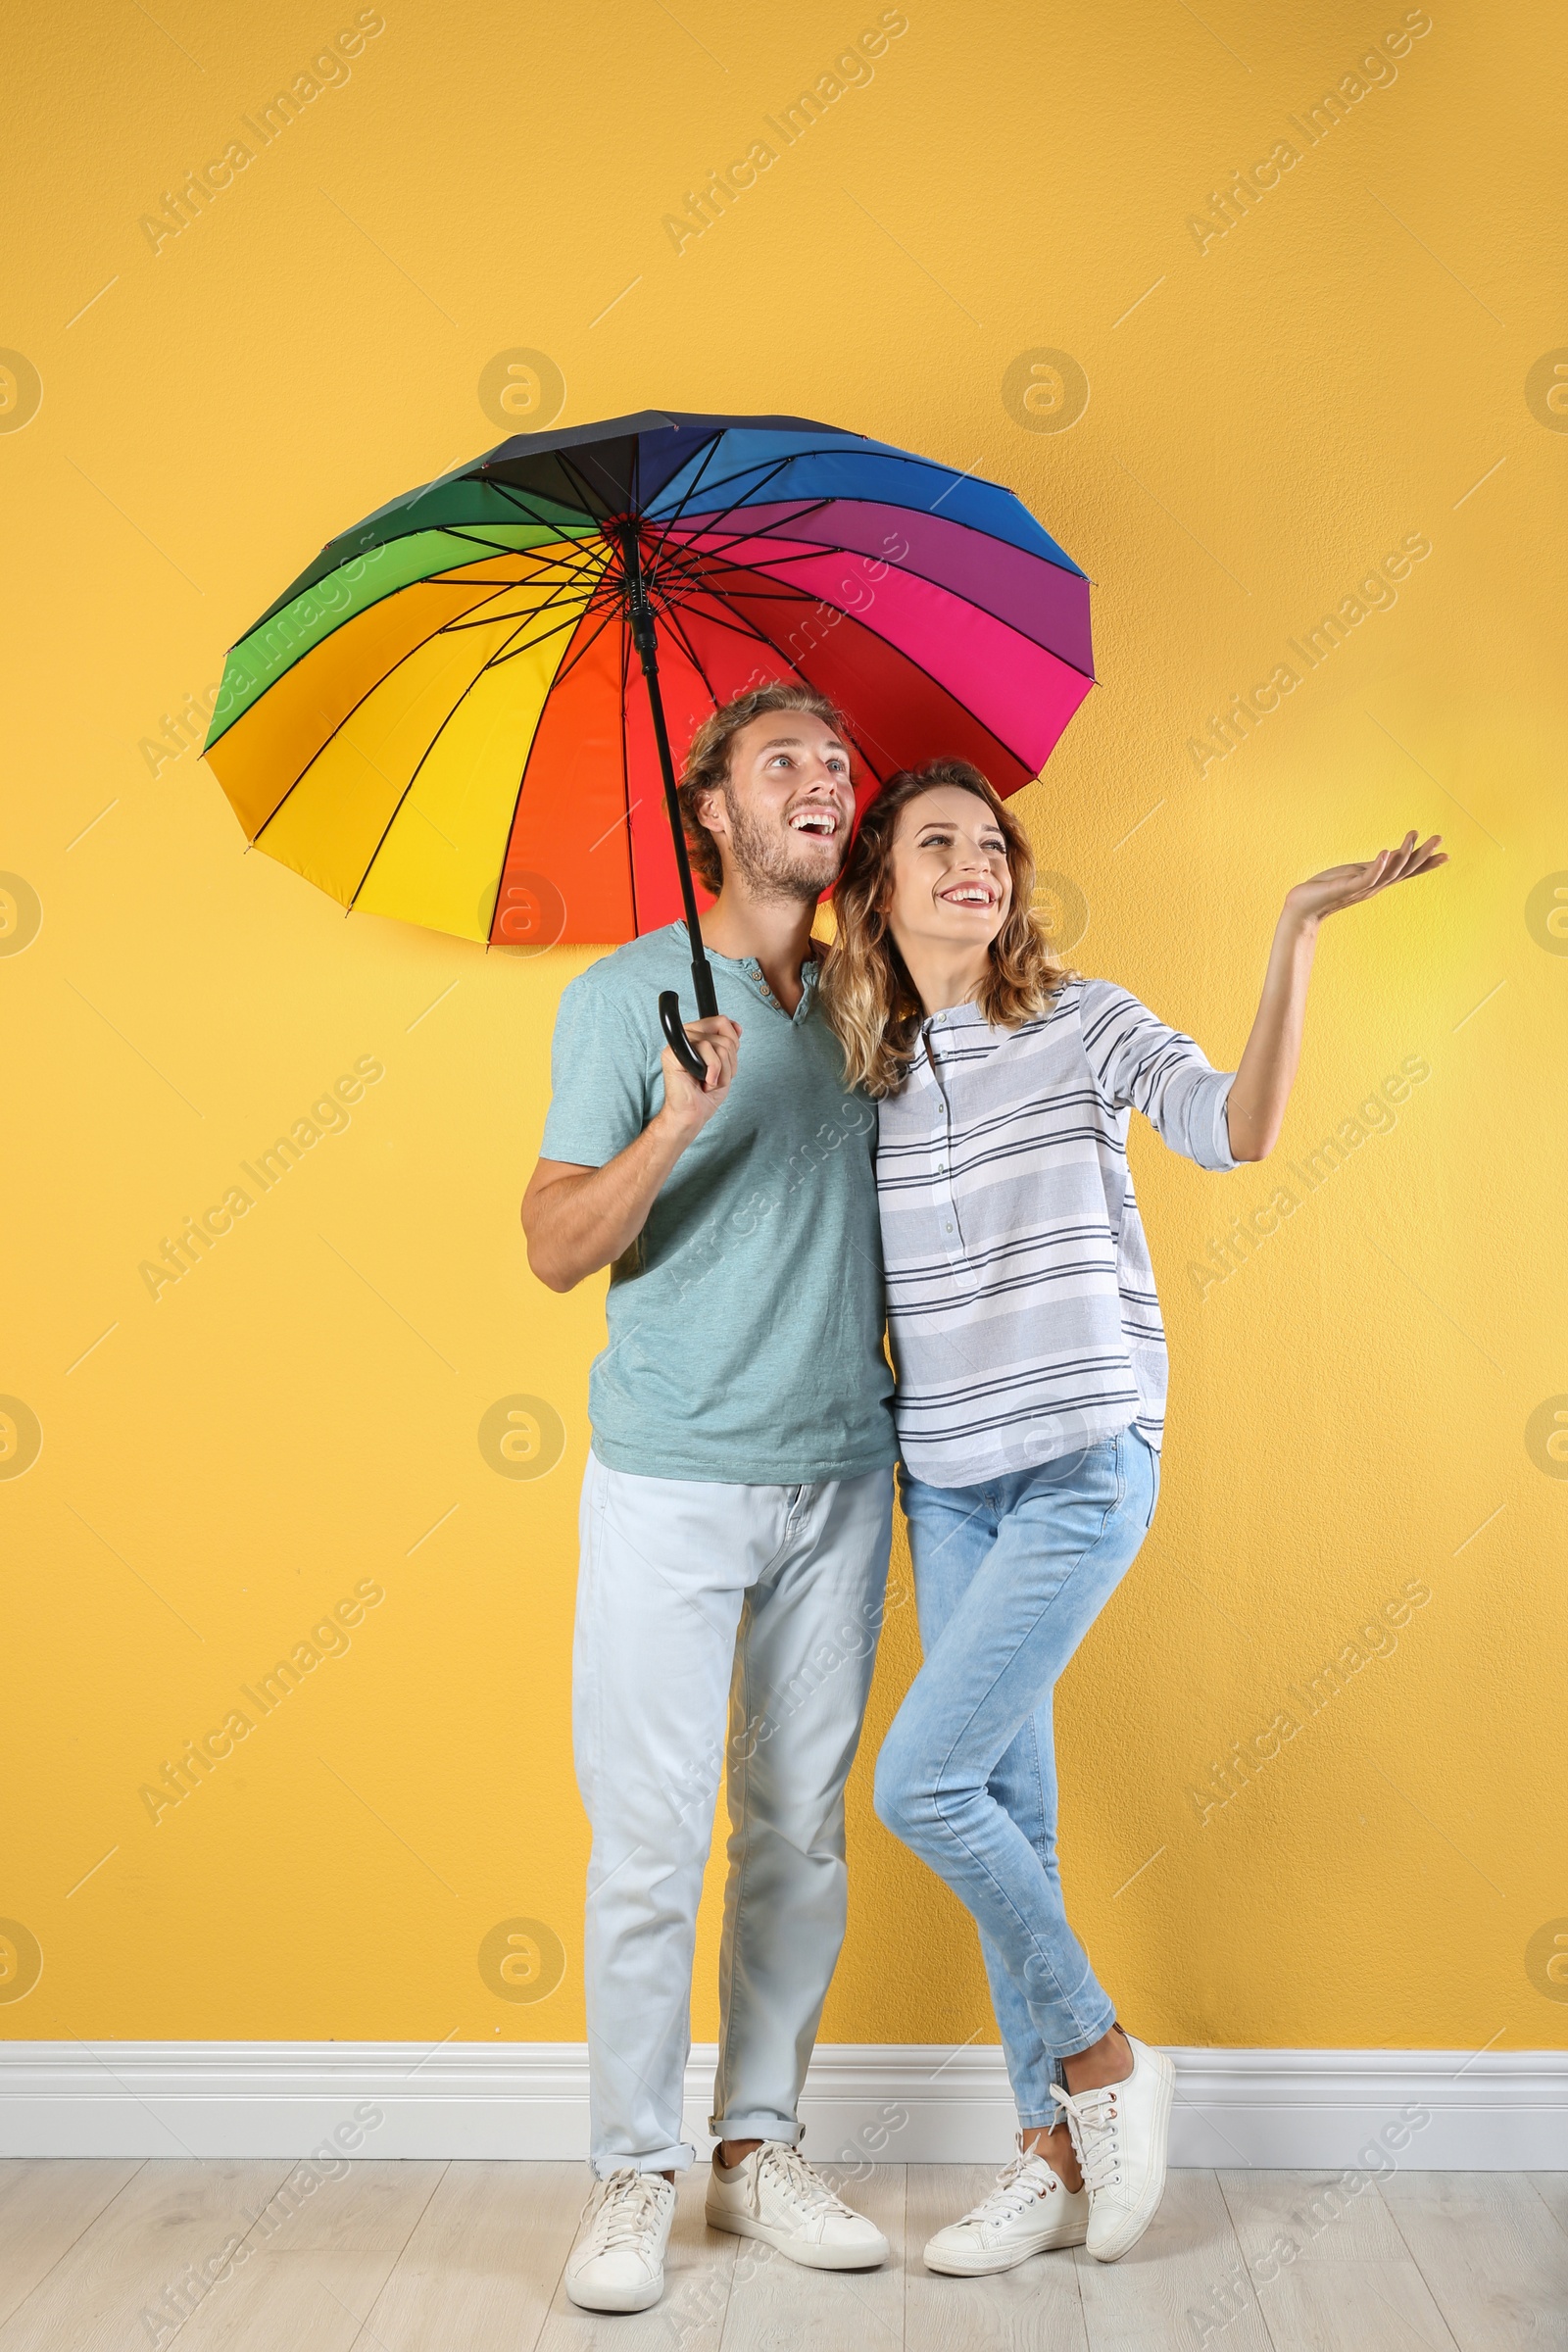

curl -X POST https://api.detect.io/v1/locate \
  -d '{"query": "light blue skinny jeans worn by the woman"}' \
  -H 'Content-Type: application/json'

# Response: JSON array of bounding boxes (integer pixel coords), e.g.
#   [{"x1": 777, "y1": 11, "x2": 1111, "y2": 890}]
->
[{"x1": 877, "y1": 1428, "x2": 1159, "y2": 2129}]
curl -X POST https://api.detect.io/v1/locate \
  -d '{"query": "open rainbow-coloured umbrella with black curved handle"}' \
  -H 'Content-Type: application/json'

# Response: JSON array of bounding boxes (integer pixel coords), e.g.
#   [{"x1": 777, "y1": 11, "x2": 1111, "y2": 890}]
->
[{"x1": 205, "y1": 410, "x2": 1093, "y2": 1072}]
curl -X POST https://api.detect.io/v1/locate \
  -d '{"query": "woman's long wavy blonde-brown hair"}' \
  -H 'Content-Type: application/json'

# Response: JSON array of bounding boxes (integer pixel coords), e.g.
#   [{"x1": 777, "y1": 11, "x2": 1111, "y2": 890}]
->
[{"x1": 820, "y1": 760, "x2": 1074, "y2": 1099}]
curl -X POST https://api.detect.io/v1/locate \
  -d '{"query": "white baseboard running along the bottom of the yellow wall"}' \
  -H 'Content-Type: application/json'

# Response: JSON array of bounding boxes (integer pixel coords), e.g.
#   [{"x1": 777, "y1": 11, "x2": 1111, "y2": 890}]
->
[{"x1": 0, "y1": 2041, "x2": 1568, "y2": 2171}]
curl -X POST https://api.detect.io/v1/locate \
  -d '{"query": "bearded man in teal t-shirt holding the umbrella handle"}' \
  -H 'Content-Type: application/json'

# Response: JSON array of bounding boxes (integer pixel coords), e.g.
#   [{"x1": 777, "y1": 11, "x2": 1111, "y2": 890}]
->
[{"x1": 522, "y1": 684, "x2": 896, "y2": 2312}]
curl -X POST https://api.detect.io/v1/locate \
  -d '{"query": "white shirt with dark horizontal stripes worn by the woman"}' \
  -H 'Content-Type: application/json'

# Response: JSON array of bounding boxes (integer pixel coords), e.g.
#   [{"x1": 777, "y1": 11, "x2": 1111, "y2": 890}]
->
[{"x1": 877, "y1": 981, "x2": 1237, "y2": 1487}]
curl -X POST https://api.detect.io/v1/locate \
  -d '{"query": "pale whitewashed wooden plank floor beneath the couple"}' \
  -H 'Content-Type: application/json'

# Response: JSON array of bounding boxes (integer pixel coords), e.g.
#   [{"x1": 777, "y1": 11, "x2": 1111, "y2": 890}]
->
[{"x1": 0, "y1": 2162, "x2": 1568, "y2": 2352}]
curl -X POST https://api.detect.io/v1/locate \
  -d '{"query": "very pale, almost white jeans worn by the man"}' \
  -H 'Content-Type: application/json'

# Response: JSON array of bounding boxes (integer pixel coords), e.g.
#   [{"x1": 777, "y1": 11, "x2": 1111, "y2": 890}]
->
[{"x1": 571, "y1": 1453, "x2": 894, "y2": 2178}]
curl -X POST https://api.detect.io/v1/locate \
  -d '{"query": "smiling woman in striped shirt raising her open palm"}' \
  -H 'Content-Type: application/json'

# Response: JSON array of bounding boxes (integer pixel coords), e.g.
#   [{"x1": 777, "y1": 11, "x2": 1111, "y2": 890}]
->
[{"x1": 823, "y1": 760, "x2": 1446, "y2": 2275}]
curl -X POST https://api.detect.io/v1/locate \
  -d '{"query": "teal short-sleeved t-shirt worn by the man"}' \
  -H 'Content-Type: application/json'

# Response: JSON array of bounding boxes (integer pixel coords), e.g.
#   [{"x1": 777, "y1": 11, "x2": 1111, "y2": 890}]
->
[{"x1": 541, "y1": 924, "x2": 898, "y2": 1487}]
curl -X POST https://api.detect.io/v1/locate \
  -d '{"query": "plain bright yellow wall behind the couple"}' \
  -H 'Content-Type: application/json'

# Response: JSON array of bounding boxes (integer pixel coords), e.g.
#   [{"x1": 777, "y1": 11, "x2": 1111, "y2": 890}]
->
[{"x1": 0, "y1": 0, "x2": 1568, "y2": 2048}]
